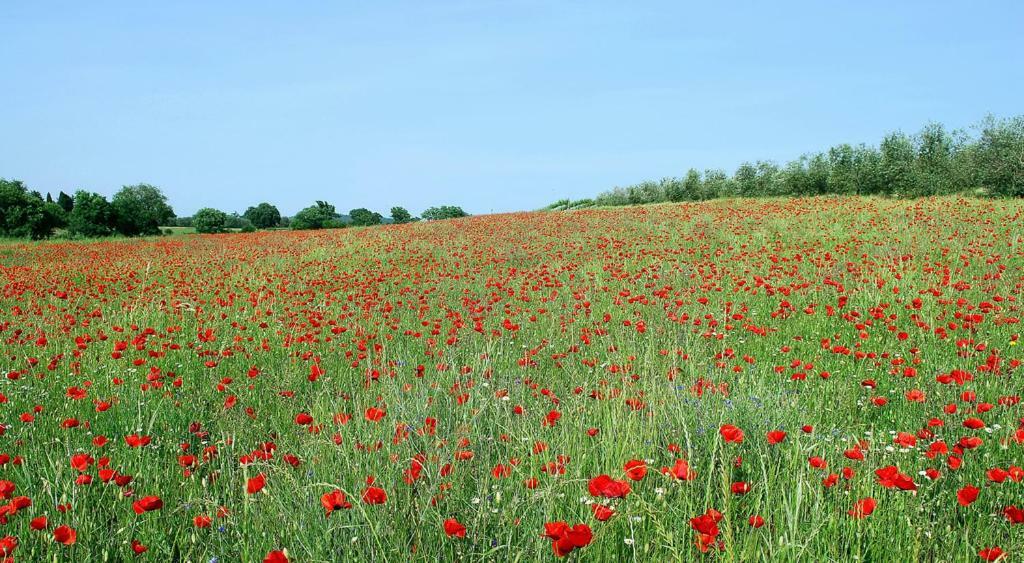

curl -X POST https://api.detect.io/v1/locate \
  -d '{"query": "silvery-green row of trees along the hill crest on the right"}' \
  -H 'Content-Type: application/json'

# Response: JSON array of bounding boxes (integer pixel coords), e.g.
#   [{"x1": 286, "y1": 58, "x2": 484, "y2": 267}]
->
[{"x1": 545, "y1": 116, "x2": 1024, "y2": 210}]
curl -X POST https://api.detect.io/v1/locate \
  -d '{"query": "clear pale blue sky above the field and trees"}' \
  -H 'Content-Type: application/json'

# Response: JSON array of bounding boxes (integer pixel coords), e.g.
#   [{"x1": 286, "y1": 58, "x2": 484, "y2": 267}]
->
[{"x1": 0, "y1": 0, "x2": 1024, "y2": 215}]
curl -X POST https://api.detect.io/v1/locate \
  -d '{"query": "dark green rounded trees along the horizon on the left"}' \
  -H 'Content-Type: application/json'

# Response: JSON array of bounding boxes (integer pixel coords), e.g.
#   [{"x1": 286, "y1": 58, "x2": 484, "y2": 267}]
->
[{"x1": 0, "y1": 178, "x2": 468, "y2": 240}]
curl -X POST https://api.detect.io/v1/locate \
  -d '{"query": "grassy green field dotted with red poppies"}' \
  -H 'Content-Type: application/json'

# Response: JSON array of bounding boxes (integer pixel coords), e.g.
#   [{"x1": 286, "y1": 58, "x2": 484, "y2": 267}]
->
[{"x1": 0, "y1": 198, "x2": 1024, "y2": 562}]
